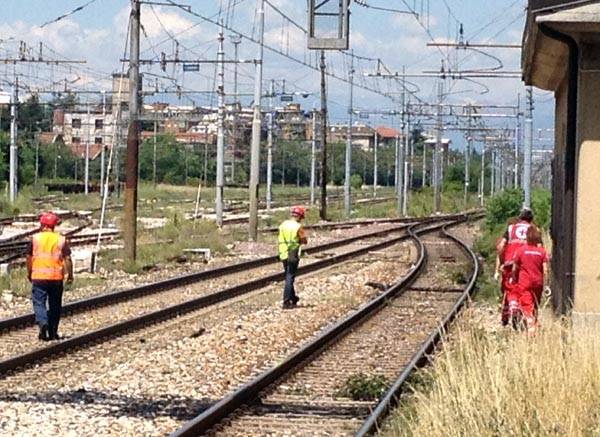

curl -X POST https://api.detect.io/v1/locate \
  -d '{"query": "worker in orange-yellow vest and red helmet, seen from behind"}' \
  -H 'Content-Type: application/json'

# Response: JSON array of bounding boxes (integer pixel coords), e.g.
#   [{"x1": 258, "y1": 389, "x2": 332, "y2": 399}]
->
[{"x1": 27, "y1": 212, "x2": 73, "y2": 341}]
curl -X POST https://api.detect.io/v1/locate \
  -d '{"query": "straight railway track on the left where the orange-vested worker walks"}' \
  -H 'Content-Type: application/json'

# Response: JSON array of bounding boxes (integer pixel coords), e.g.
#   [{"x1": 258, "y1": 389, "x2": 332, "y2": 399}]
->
[{"x1": 0, "y1": 221, "x2": 426, "y2": 374}]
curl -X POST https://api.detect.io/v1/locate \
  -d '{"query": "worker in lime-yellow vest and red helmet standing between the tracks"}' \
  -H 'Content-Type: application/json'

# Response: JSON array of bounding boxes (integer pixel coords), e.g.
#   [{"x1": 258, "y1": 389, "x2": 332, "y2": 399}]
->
[{"x1": 278, "y1": 206, "x2": 308, "y2": 309}]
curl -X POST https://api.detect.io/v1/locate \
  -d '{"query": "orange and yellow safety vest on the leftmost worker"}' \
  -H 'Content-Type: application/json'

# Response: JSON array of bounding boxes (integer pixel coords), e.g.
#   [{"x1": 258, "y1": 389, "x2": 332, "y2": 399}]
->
[{"x1": 31, "y1": 231, "x2": 66, "y2": 281}]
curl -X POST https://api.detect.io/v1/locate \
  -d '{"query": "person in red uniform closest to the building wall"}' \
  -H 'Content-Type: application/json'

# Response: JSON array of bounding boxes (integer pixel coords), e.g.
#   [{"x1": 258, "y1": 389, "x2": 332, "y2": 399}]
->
[{"x1": 508, "y1": 226, "x2": 548, "y2": 334}]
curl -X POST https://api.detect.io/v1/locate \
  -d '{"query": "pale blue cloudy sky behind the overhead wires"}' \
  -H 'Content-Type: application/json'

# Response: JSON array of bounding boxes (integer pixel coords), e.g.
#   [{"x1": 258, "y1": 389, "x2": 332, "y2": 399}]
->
[{"x1": 0, "y1": 0, "x2": 553, "y2": 151}]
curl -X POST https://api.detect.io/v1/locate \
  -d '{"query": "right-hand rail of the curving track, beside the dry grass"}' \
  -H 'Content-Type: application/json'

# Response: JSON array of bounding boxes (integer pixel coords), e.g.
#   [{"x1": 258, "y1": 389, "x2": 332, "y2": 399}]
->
[{"x1": 356, "y1": 226, "x2": 480, "y2": 437}]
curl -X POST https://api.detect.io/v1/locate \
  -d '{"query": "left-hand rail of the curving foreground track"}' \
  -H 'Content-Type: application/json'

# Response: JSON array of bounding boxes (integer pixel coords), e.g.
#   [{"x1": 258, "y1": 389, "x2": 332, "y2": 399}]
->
[{"x1": 171, "y1": 219, "x2": 450, "y2": 437}]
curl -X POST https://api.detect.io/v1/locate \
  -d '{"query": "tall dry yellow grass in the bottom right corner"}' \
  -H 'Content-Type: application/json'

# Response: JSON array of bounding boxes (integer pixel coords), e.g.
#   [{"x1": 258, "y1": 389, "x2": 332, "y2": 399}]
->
[{"x1": 385, "y1": 308, "x2": 600, "y2": 436}]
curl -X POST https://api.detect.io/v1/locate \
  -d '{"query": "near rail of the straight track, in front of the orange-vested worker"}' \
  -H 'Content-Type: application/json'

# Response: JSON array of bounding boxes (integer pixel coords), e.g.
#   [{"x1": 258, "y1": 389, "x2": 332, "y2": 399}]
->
[{"x1": 0, "y1": 221, "x2": 428, "y2": 375}]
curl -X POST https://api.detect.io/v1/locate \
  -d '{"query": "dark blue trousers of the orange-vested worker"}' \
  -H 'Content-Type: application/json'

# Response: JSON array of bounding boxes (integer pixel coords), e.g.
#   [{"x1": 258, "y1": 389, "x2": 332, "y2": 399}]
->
[{"x1": 31, "y1": 281, "x2": 63, "y2": 337}]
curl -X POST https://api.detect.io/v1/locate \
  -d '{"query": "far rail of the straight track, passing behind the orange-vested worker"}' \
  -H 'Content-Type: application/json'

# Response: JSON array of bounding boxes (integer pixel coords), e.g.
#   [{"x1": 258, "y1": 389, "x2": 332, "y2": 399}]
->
[{"x1": 0, "y1": 226, "x2": 407, "y2": 332}]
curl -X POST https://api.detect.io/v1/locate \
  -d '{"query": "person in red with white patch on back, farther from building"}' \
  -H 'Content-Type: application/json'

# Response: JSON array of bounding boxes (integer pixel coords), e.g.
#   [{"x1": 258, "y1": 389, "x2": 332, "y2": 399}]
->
[{"x1": 496, "y1": 208, "x2": 533, "y2": 326}]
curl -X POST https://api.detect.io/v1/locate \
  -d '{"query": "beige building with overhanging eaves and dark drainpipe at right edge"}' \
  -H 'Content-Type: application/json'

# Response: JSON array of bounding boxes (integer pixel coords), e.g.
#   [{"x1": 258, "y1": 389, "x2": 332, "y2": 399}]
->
[{"x1": 522, "y1": 0, "x2": 600, "y2": 320}]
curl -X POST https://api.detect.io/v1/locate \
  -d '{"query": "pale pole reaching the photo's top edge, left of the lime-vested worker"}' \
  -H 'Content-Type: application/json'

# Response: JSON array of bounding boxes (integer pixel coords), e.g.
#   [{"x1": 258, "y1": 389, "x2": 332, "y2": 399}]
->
[{"x1": 248, "y1": 0, "x2": 265, "y2": 241}]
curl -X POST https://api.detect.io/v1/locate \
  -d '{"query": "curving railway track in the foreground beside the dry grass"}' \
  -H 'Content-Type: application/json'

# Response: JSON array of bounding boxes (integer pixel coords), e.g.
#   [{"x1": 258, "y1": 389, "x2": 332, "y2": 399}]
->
[{"x1": 173, "y1": 217, "x2": 478, "y2": 436}]
